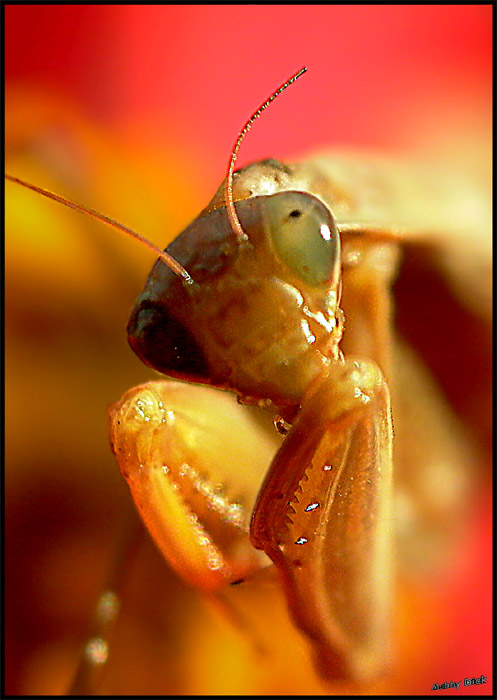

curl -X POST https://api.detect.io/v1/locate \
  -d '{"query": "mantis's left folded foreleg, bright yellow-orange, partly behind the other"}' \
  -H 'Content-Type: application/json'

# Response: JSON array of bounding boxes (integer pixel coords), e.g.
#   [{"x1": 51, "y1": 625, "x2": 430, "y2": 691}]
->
[{"x1": 109, "y1": 381, "x2": 280, "y2": 592}]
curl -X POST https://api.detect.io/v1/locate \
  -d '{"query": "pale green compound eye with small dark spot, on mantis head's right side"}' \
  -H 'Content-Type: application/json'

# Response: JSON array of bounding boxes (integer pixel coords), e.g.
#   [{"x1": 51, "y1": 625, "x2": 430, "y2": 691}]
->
[{"x1": 263, "y1": 192, "x2": 340, "y2": 287}]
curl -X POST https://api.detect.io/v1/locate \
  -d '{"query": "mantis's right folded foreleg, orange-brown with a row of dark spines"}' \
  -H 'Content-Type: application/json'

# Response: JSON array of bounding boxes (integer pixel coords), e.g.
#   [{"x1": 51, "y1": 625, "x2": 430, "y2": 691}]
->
[{"x1": 251, "y1": 360, "x2": 392, "y2": 680}]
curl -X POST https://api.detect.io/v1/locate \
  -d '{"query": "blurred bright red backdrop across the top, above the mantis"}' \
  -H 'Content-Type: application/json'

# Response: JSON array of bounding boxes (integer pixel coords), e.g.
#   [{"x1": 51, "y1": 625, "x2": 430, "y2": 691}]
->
[{"x1": 6, "y1": 5, "x2": 492, "y2": 165}]
